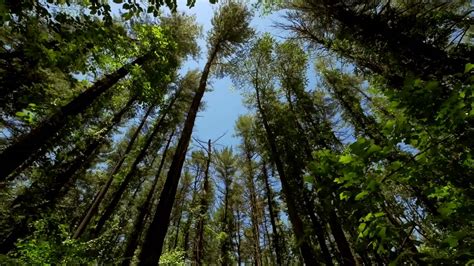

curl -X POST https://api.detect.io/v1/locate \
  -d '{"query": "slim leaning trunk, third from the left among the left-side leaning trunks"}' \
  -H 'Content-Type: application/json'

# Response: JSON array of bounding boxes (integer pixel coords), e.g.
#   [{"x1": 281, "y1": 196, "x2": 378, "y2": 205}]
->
[{"x1": 72, "y1": 101, "x2": 155, "y2": 239}]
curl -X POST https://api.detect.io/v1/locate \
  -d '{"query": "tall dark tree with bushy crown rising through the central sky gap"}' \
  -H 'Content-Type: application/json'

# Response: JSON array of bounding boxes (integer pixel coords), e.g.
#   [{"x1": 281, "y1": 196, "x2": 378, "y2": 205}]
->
[{"x1": 140, "y1": 2, "x2": 252, "y2": 264}]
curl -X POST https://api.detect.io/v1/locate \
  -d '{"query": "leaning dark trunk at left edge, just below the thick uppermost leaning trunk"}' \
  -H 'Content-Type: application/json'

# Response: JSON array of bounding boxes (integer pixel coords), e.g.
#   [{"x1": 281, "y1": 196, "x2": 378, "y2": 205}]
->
[{"x1": 0, "y1": 99, "x2": 134, "y2": 254}]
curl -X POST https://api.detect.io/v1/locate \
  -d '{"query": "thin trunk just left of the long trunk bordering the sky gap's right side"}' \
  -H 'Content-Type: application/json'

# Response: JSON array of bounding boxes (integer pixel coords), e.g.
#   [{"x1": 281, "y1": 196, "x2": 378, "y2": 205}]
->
[{"x1": 262, "y1": 161, "x2": 283, "y2": 266}]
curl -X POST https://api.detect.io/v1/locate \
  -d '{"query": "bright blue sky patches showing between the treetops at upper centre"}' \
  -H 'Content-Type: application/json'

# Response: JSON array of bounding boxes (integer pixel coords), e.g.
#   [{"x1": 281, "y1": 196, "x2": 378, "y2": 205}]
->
[{"x1": 178, "y1": 0, "x2": 284, "y2": 146}]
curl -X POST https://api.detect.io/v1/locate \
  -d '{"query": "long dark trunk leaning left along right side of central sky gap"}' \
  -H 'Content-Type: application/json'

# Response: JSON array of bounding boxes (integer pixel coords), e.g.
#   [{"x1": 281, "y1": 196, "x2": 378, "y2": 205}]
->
[{"x1": 254, "y1": 77, "x2": 320, "y2": 265}]
